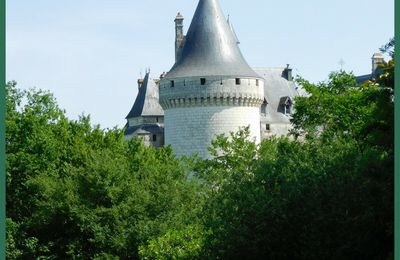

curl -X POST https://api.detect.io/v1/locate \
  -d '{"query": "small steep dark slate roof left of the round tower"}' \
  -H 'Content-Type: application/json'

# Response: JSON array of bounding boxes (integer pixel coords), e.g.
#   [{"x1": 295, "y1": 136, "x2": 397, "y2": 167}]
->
[{"x1": 126, "y1": 72, "x2": 164, "y2": 119}]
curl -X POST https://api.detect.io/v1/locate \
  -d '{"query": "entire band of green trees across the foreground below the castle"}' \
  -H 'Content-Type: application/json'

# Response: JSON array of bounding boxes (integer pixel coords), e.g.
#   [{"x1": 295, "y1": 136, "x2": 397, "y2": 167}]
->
[{"x1": 6, "y1": 46, "x2": 394, "y2": 259}]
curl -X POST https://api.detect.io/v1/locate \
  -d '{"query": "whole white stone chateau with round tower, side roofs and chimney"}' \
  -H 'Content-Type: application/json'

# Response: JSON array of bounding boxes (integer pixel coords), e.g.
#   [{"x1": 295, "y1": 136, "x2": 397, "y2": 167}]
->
[{"x1": 125, "y1": 0, "x2": 299, "y2": 158}]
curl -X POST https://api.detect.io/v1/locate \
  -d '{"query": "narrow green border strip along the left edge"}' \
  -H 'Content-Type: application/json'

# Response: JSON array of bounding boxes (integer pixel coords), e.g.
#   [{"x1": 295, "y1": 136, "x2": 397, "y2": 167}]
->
[{"x1": 0, "y1": 0, "x2": 6, "y2": 259}]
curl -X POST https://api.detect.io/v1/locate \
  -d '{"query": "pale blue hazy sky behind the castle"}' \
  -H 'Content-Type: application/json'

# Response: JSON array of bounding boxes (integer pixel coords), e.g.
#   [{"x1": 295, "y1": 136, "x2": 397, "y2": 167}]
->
[{"x1": 6, "y1": 0, "x2": 394, "y2": 128}]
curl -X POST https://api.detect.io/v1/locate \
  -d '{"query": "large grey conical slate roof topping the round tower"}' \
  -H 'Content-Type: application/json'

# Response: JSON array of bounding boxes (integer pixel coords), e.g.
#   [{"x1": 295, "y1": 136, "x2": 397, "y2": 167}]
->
[{"x1": 166, "y1": 0, "x2": 259, "y2": 78}]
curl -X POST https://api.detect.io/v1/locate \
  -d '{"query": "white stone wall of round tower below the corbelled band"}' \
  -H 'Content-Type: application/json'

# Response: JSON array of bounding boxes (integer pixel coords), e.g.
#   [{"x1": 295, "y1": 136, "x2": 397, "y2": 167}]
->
[{"x1": 165, "y1": 106, "x2": 260, "y2": 158}]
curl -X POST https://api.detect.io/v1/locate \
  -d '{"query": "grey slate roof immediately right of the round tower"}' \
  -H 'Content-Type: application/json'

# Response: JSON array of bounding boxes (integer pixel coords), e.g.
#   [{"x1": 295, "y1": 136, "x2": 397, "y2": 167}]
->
[{"x1": 254, "y1": 68, "x2": 299, "y2": 123}]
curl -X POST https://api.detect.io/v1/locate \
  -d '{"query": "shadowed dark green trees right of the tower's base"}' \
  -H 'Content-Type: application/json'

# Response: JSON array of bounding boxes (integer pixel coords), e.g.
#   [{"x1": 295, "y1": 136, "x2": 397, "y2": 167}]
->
[{"x1": 199, "y1": 68, "x2": 394, "y2": 259}]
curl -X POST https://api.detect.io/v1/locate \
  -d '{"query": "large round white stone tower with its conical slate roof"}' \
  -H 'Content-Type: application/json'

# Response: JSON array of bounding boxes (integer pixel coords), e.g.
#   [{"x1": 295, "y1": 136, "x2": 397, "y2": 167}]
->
[{"x1": 159, "y1": 0, "x2": 264, "y2": 158}]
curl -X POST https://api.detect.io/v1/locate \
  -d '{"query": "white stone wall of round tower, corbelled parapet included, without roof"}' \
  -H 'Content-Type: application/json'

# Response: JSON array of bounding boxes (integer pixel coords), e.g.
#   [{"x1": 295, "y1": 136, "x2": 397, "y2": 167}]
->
[{"x1": 160, "y1": 77, "x2": 264, "y2": 158}]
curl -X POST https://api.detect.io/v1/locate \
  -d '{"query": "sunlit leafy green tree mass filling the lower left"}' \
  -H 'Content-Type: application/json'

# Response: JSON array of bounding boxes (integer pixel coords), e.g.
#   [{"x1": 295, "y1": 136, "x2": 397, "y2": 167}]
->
[{"x1": 6, "y1": 82, "x2": 203, "y2": 259}]
